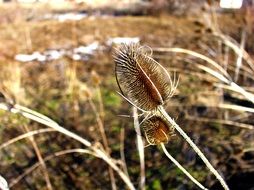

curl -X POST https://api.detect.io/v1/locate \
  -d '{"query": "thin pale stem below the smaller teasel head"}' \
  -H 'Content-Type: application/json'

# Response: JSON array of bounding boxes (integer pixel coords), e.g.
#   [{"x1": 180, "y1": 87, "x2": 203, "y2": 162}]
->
[{"x1": 161, "y1": 143, "x2": 208, "y2": 190}]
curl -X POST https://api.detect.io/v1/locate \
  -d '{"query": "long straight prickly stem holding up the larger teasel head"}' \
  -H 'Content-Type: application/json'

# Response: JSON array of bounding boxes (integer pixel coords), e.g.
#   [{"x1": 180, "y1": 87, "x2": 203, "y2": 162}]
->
[{"x1": 158, "y1": 106, "x2": 229, "y2": 190}]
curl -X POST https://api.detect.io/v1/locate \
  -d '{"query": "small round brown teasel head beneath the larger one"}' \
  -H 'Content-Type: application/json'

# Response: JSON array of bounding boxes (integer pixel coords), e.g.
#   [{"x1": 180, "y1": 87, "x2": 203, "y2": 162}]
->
[{"x1": 142, "y1": 116, "x2": 174, "y2": 145}]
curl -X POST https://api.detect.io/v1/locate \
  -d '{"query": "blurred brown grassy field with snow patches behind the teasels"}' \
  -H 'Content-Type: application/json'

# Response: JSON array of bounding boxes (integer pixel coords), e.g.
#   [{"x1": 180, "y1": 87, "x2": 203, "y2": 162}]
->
[{"x1": 0, "y1": 0, "x2": 254, "y2": 190}]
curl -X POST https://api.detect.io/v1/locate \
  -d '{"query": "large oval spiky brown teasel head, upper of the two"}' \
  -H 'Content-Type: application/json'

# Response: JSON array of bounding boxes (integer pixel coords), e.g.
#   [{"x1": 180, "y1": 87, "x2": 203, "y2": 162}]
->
[{"x1": 114, "y1": 43, "x2": 177, "y2": 111}]
